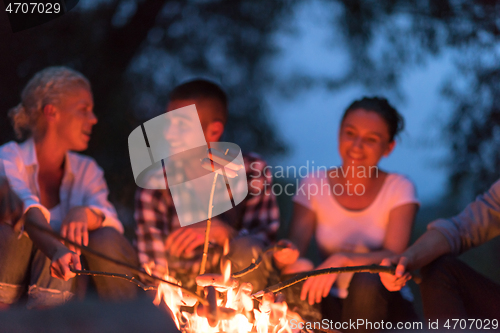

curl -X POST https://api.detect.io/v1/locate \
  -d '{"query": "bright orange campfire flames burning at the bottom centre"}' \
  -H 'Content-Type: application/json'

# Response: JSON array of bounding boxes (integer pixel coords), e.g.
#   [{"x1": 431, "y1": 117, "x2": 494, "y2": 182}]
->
[{"x1": 145, "y1": 253, "x2": 302, "y2": 333}]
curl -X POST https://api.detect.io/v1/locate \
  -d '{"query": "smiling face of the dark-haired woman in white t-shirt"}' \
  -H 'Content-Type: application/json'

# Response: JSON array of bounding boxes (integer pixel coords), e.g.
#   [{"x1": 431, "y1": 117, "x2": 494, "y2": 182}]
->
[{"x1": 339, "y1": 109, "x2": 395, "y2": 167}]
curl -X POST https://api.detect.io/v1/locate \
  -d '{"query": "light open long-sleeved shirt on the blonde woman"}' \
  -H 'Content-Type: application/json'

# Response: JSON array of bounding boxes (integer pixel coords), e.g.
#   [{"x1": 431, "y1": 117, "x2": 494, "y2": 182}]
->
[{"x1": 0, "y1": 138, "x2": 123, "y2": 233}]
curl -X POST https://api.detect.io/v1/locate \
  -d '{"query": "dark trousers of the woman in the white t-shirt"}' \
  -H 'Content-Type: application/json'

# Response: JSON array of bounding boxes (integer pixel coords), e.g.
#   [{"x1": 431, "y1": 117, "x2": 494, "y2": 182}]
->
[{"x1": 321, "y1": 273, "x2": 418, "y2": 332}]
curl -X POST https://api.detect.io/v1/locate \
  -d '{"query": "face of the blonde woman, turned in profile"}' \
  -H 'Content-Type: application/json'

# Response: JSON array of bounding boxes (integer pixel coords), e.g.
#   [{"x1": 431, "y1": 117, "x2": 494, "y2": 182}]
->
[{"x1": 54, "y1": 87, "x2": 97, "y2": 151}]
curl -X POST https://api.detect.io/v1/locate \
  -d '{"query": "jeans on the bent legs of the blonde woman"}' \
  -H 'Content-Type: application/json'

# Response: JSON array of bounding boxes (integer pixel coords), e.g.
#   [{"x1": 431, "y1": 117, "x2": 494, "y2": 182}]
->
[{"x1": 0, "y1": 224, "x2": 138, "y2": 308}]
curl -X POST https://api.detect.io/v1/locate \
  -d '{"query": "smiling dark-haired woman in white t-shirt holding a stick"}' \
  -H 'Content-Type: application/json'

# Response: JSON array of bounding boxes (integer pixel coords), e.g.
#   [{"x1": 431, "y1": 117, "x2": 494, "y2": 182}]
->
[{"x1": 284, "y1": 97, "x2": 419, "y2": 330}]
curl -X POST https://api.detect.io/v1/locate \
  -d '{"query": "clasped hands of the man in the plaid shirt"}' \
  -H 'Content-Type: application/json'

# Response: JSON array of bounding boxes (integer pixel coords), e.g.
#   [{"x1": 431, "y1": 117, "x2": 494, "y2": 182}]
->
[{"x1": 165, "y1": 219, "x2": 235, "y2": 257}]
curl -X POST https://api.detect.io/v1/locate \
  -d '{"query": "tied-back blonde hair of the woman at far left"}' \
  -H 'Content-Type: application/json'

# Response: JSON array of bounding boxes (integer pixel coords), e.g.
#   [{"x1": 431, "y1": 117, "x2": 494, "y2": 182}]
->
[{"x1": 9, "y1": 67, "x2": 90, "y2": 139}]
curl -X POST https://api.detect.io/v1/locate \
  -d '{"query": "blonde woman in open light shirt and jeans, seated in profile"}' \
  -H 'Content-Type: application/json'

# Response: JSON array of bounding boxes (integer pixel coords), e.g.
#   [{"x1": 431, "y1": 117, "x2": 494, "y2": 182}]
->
[{"x1": 0, "y1": 67, "x2": 137, "y2": 308}]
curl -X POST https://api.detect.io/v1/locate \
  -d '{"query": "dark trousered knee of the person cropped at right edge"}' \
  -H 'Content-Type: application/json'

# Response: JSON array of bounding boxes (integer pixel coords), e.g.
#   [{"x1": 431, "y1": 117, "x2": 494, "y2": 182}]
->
[{"x1": 420, "y1": 255, "x2": 500, "y2": 322}]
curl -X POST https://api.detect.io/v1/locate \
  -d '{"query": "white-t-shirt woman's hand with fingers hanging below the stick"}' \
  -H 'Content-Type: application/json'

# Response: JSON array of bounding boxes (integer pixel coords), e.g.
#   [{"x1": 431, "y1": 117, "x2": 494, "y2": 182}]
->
[{"x1": 300, "y1": 253, "x2": 349, "y2": 305}]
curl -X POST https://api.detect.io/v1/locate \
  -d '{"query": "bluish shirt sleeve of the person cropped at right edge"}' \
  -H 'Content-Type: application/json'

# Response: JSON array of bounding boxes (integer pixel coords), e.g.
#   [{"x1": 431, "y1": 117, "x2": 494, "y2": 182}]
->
[{"x1": 427, "y1": 180, "x2": 500, "y2": 254}]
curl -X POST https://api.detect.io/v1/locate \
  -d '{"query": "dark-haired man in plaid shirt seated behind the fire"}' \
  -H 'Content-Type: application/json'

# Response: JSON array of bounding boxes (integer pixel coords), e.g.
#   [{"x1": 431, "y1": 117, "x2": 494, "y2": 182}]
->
[{"x1": 135, "y1": 80, "x2": 279, "y2": 290}]
